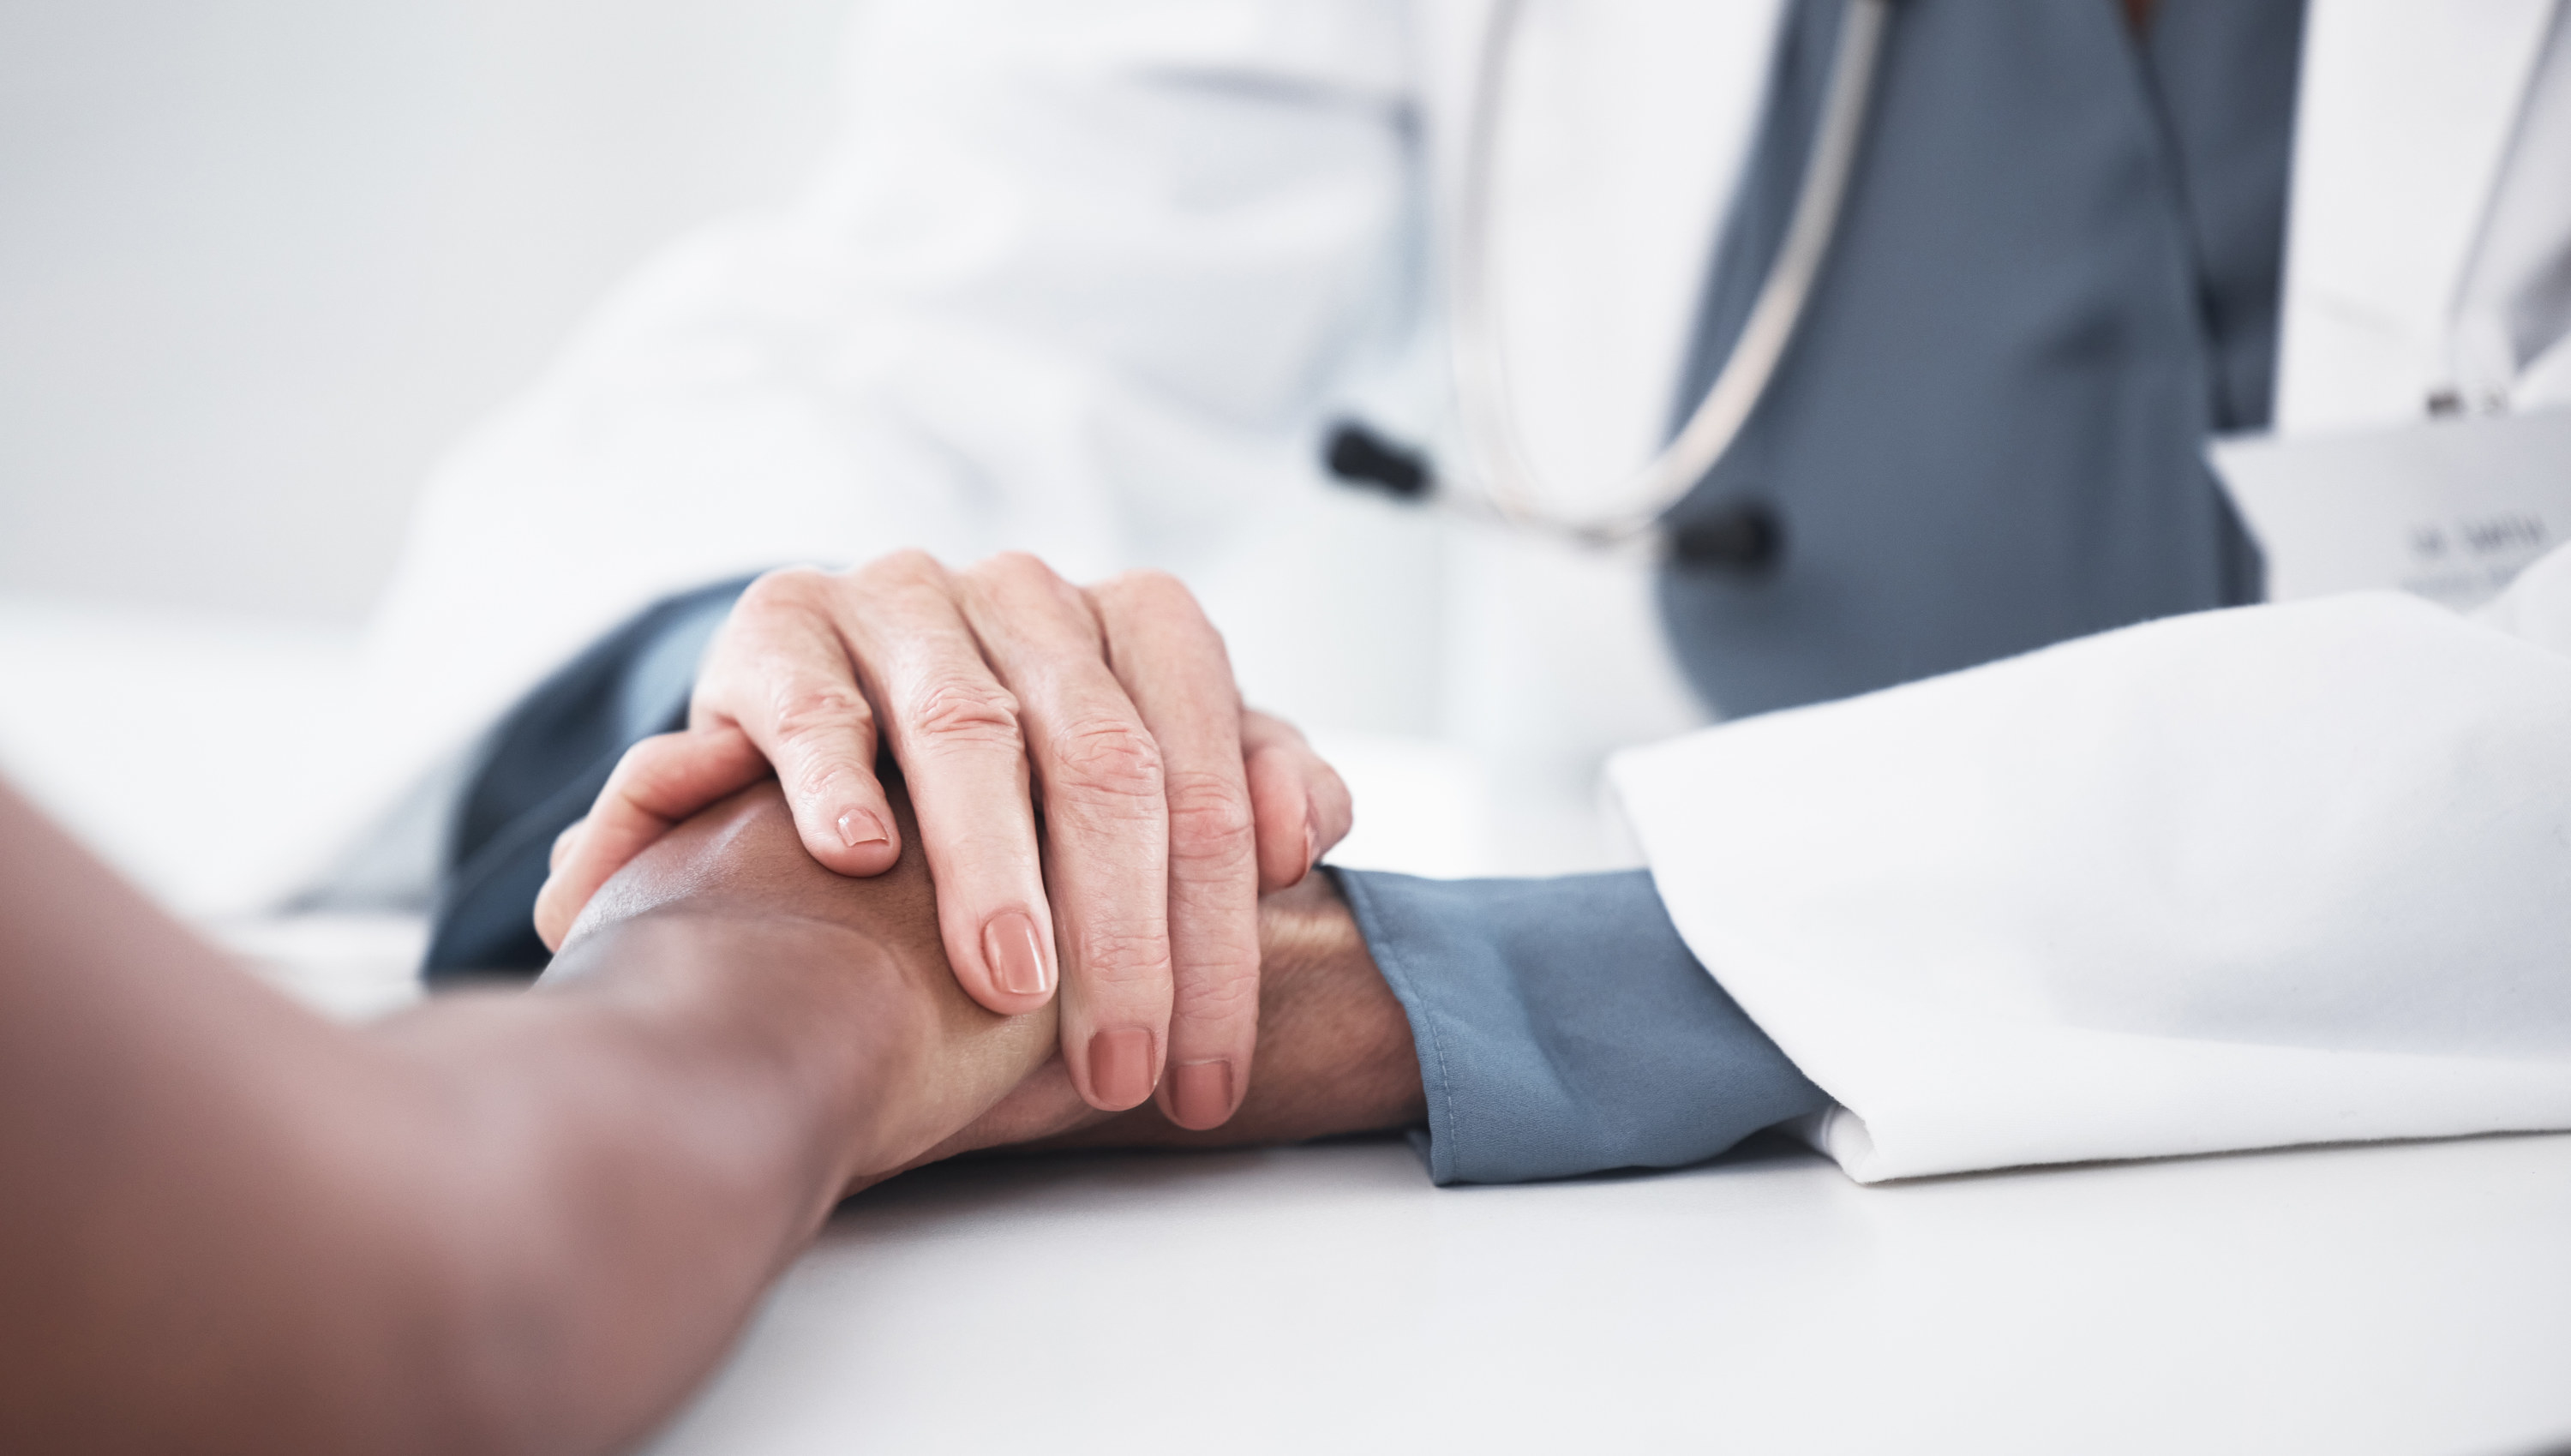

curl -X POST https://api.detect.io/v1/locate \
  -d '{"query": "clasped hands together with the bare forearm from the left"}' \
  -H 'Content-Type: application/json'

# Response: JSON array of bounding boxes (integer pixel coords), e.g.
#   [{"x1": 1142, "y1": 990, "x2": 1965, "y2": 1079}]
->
[{"x1": 0, "y1": 555, "x2": 1424, "y2": 1451}]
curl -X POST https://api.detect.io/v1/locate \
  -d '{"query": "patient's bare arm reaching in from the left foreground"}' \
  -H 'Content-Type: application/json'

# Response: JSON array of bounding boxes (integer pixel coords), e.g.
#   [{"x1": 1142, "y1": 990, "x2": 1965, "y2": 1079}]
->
[{"x1": 0, "y1": 793, "x2": 1052, "y2": 1451}]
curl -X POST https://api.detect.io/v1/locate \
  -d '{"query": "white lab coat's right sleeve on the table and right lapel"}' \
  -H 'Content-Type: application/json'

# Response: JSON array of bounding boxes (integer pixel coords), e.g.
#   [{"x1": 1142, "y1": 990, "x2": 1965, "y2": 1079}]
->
[{"x1": 1615, "y1": 0, "x2": 2571, "y2": 1181}]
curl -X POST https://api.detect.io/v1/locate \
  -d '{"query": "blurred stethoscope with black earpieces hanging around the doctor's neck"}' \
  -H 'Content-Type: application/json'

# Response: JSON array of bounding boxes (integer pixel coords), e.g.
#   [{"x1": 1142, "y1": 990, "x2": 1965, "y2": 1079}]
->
[{"x1": 1321, "y1": 0, "x2": 1892, "y2": 566}]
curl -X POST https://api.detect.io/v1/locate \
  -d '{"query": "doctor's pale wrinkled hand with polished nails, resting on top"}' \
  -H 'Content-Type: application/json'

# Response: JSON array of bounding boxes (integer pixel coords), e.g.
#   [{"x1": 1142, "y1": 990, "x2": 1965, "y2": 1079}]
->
[{"x1": 535, "y1": 550, "x2": 1350, "y2": 1127}]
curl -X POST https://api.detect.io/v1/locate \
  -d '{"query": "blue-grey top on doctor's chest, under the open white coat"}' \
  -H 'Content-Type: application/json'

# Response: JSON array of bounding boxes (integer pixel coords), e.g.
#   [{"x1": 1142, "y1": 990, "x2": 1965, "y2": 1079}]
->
[{"x1": 1658, "y1": 0, "x2": 2304, "y2": 715}]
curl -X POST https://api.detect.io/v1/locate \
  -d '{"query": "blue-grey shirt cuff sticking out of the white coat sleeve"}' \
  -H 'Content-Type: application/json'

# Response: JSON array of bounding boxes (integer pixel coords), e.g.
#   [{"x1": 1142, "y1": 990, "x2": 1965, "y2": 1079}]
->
[{"x1": 1334, "y1": 870, "x2": 1828, "y2": 1183}]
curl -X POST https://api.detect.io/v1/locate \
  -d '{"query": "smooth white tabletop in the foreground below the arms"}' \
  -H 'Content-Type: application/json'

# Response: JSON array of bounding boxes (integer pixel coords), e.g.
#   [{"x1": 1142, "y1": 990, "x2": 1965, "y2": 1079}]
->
[{"x1": 650, "y1": 1137, "x2": 2571, "y2": 1456}]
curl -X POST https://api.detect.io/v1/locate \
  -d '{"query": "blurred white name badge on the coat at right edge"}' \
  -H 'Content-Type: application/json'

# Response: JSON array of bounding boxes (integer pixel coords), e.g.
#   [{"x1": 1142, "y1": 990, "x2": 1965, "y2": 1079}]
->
[{"x1": 2208, "y1": 409, "x2": 2571, "y2": 609}]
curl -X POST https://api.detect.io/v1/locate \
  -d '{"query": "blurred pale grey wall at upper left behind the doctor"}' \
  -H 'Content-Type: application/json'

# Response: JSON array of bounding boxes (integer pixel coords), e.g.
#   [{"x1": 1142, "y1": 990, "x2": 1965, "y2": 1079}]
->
[{"x1": 0, "y1": 0, "x2": 848, "y2": 627}]
